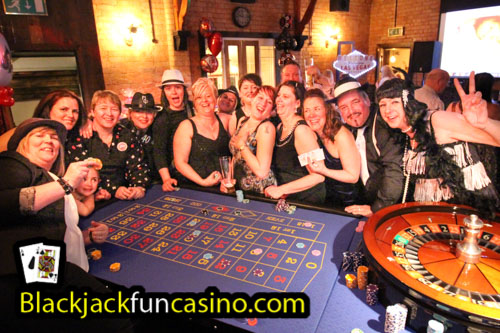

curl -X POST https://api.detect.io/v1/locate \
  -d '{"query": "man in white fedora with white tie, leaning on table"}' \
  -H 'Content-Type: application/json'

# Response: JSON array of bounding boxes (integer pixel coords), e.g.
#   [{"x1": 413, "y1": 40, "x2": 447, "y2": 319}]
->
[{"x1": 334, "y1": 76, "x2": 404, "y2": 217}]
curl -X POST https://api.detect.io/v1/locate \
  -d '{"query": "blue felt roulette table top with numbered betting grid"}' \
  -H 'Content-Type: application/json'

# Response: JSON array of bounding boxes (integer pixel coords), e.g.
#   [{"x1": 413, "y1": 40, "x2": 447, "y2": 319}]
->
[{"x1": 80, "y1": 186, "x2": 410, "y2": 333}]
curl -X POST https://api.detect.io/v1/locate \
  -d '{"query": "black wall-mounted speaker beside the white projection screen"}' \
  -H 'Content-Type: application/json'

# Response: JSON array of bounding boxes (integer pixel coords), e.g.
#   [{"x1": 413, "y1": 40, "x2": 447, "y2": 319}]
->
[{"x1": 410, "y1": 41, "x2": 442, "y2": 73}]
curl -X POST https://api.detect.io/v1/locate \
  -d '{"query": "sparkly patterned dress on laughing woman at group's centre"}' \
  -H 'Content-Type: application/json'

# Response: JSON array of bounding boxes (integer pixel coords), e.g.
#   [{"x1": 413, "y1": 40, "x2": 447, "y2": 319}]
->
[{"x1": 229, "y1": 118, "x2": 277, "y2": 194}]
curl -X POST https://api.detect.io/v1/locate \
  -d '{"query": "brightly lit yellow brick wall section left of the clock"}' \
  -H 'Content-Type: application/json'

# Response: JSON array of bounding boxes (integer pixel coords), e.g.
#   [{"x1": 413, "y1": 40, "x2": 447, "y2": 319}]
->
[{"x1": 93, "y1": 0, "x2": 189, "y2": 103}]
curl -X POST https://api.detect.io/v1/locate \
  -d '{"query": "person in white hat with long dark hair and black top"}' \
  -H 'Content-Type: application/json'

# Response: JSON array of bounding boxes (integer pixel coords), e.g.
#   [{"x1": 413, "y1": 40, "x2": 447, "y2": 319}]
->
[{"x1": 153, "y1": 69, "x2": 194, "y2": 191}]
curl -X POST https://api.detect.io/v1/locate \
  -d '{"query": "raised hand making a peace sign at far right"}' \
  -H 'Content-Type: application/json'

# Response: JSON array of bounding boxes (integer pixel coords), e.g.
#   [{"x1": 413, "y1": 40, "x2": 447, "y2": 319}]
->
[{"x1": 453, "y1": 71, "x2": 488, "y2": 129}]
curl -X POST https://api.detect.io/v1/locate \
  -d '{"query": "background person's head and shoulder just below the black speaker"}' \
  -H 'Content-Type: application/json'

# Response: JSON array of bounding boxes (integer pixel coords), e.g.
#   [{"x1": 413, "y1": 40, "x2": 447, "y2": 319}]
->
[{"x1": 415, "y1": 68, "x2": 450, "y2": 110}]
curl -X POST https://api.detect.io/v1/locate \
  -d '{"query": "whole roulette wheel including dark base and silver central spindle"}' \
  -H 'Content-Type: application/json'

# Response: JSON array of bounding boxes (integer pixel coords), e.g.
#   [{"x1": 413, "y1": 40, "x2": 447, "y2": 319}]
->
[{"x1": 363, "y1": 203, "x2": 500, "y2": 332}]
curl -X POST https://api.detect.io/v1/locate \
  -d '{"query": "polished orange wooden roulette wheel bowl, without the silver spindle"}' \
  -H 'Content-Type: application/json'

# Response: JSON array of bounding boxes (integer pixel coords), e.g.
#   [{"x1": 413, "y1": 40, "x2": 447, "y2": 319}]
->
[{"x1": 363, "y1": 202, "x2": 500, "y2": 327}]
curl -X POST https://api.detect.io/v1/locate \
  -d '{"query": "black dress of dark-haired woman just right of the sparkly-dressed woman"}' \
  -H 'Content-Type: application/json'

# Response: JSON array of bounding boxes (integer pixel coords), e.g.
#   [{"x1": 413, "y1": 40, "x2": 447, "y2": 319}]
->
[{"x1": 273, "y1": 120, "x2": 326, "y2": 204}]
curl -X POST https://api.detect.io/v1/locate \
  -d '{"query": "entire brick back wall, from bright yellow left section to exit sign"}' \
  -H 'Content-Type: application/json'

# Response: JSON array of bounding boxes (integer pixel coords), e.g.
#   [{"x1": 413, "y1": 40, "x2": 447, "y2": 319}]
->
[{"x1": 93, "y1": 0, "x2": 440, "y2": 94}]
